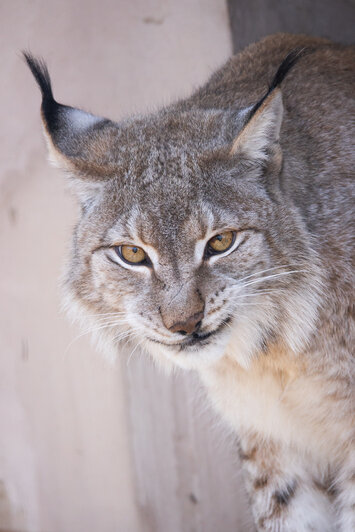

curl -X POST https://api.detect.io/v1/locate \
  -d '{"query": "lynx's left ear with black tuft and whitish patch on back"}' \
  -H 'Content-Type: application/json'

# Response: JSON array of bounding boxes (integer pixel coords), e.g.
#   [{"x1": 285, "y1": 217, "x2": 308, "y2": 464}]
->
[{"x1": 24, "y1": 52, "x2": 119, "y2": 181}]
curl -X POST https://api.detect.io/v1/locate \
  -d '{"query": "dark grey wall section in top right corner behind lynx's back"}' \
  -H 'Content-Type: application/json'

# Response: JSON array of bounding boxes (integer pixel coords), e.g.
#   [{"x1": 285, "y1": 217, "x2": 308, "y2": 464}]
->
[{"x1": 228, "y1": 0, "x2": 355, "y2": 52}]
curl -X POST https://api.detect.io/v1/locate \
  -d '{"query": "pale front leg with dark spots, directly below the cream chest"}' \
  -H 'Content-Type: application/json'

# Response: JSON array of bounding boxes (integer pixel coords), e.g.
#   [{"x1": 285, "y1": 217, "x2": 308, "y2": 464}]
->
[{"x1": 240, "y1": 435, "x2": 336, "y2": 532}]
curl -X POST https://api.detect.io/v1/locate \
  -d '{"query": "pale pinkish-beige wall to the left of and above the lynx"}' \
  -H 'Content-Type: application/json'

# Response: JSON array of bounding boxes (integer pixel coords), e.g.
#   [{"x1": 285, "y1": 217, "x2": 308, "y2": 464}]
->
[{"x1": 0, "y1": 0, "x2": 247, "y2": 532}]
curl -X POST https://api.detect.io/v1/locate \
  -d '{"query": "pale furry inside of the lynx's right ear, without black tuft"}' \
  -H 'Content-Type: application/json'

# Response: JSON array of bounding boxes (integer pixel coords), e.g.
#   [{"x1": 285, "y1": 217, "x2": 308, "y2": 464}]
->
[{"x1": 231, "y1": 89, "x2": 283, "y2": 163}]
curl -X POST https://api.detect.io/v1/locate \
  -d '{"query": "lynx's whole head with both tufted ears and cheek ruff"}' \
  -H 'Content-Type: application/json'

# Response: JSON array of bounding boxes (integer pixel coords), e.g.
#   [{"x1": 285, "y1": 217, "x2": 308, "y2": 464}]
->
[{"x1": 26, "y1": 54, "x2": 317, "y2": 368}]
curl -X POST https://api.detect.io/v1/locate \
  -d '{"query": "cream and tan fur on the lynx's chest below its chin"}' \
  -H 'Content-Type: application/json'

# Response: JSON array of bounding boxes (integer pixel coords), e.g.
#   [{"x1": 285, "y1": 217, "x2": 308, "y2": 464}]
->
[{"x1": 201, "y1": 355, "x2": 348, "y2": 460}]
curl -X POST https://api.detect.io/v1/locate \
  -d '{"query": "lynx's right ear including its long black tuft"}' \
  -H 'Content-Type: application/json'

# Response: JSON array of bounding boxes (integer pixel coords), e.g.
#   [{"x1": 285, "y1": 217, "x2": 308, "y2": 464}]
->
[{"x1": 231, "y1": 48, "x2": 312, "y2": 163}]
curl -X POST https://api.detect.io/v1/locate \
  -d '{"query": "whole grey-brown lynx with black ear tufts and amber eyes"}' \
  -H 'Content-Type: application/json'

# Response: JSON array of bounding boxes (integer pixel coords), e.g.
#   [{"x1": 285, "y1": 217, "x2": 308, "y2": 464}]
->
[{"x1": 25, "y1": 34, "x2": 355, "y2": 532}]
